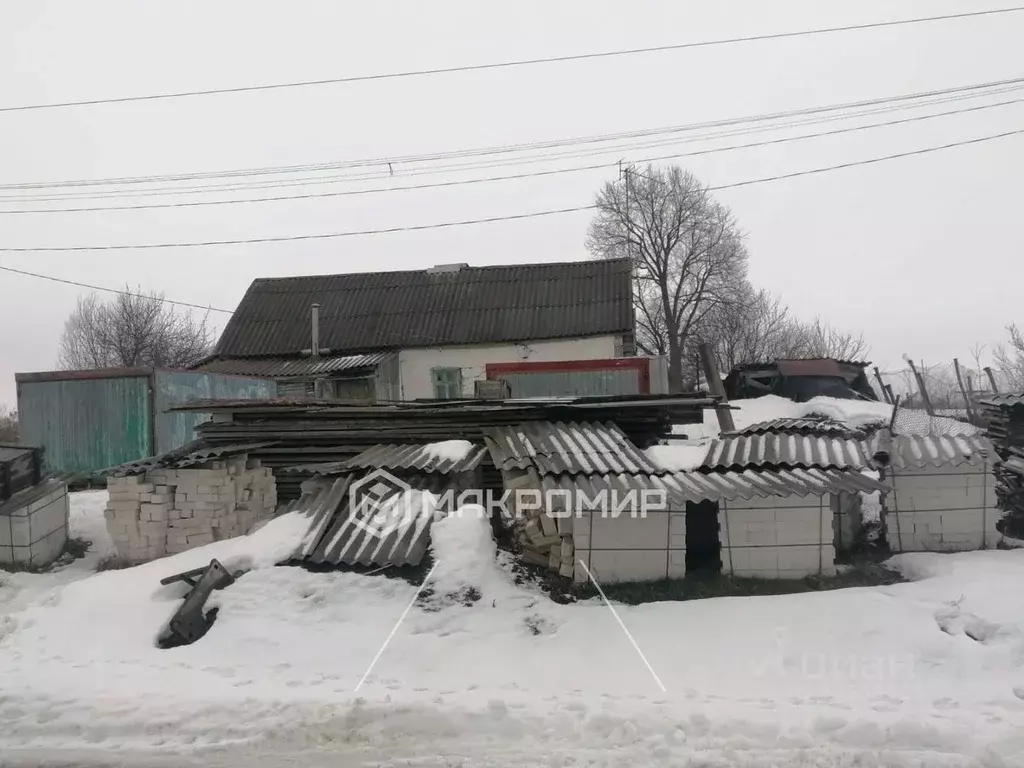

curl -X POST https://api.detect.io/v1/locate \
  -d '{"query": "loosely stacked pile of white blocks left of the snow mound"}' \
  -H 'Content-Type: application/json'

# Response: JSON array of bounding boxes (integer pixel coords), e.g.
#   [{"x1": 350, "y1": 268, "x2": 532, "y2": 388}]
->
[{"x1": 105, "y1": 456, "x2": 278, "y2": 562}]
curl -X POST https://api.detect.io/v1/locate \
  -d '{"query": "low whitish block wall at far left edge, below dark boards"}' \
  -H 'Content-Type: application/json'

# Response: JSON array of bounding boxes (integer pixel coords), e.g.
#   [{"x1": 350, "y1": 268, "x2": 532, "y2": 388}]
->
[{"x1": 0, "y1": 481, "x2": 69, "y2": 567}]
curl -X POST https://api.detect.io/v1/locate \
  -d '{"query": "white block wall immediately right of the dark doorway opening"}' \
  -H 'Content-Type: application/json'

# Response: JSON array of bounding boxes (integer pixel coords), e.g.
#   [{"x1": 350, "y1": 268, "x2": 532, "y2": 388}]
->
[{"x1": 718, "y1": 495, "x2": 836, "y2": 579}]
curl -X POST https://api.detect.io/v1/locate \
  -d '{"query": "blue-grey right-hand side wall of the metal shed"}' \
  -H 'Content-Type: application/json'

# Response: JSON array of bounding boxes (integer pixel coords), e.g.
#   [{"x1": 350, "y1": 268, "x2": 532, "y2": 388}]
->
[{"x1": 151, "y1": 370, "x2": 278, "y2": 454}]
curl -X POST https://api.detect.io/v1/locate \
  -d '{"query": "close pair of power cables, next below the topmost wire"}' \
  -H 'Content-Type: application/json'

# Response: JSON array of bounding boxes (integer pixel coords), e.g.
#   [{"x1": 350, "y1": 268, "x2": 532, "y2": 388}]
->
[{"x1": 0, "y1": 77, "x2": 1024, "y2": 200}]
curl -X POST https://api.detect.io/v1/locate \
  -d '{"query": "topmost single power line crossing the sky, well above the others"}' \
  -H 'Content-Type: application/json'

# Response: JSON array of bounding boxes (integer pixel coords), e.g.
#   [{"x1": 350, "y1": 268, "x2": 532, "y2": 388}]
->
[{"x1": 0, "y1": 6, "x2": 1024, "y2": 112}]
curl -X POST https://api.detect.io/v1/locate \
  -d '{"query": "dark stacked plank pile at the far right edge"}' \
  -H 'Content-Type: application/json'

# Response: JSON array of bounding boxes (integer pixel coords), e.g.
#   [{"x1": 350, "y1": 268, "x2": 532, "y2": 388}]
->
[{"x1": 981, "y1": 394, "x2": 1024, "y2": 539}]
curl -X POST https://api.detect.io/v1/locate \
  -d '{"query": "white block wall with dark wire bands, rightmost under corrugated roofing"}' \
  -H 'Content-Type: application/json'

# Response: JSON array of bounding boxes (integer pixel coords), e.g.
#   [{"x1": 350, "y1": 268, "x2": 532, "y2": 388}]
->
[{"x1": 885, "y1": 465, "x2": 1002, "y2": 552}]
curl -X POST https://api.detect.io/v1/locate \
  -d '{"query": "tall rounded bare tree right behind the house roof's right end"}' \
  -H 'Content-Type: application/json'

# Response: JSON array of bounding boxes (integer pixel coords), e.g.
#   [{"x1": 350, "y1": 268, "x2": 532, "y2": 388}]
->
[{"x1": 587, "y1": 166, "x2": 746, "y2": 392}]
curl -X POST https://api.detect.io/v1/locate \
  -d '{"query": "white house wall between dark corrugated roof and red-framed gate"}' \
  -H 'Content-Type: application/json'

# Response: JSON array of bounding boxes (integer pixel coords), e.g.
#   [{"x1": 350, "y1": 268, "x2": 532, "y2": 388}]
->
[{"x1": 398, "y1": 335, "x2": 618, "y2": 400}]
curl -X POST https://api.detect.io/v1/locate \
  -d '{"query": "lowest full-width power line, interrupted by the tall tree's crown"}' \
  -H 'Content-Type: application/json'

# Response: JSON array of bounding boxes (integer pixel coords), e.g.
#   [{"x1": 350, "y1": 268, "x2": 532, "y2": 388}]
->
[{"x1": 0, "y1": 128, "x2": 1024, "y2": 253}]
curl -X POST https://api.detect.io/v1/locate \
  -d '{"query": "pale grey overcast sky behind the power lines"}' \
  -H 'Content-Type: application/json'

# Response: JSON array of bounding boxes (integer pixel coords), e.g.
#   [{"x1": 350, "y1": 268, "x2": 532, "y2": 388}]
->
[{"x1": 0, "y1": 0, "x2": 1024, "y2": 404}]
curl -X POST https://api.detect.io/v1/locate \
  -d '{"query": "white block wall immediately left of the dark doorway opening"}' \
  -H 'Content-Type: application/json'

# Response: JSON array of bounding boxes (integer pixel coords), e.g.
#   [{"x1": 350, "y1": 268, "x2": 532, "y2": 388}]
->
[{"x1": 572, "y1": 510, "x2": 686, "y2": 584}]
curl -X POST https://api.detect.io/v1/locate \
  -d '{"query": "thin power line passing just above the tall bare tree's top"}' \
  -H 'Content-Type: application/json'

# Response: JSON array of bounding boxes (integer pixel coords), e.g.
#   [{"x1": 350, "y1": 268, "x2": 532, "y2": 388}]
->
[{"x1": 8, "y1": 98, "x2": 1024, "y2": 215}]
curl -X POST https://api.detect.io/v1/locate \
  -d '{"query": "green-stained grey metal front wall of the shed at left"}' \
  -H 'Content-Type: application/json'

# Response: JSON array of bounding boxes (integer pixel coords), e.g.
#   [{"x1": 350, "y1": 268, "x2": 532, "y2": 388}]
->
[{"x1": 17, "y1": 374, "x2": 154, "y2": 473}]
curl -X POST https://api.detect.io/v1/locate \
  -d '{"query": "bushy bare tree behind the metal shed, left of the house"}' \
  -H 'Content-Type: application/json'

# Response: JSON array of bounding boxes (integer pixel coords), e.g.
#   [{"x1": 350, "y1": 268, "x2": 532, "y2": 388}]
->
[{"x1": 58, "y1": 290, "x2": 214, "y2": 369}]
